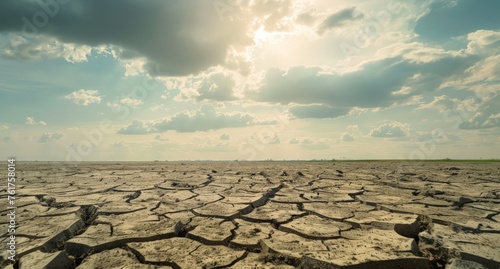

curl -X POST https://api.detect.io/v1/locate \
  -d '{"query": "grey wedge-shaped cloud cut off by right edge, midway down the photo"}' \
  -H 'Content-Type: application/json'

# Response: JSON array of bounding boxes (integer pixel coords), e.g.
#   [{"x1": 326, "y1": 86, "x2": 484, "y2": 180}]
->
[{"x1": 459, "y1": 94, "x2": 500, "y2": 129}]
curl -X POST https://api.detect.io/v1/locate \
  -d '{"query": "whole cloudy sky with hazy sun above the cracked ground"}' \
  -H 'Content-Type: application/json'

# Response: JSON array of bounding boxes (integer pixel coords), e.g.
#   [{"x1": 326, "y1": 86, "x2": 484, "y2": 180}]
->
[{"x1": 0, "y1": 0, "x2": 500, "y2": 162}]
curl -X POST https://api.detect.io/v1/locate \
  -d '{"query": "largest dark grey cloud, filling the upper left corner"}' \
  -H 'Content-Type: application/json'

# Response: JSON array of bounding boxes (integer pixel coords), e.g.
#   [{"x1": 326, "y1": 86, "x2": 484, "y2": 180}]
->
[{"x1": 0, "y1": 0, "x2": 250, "y2": 76}]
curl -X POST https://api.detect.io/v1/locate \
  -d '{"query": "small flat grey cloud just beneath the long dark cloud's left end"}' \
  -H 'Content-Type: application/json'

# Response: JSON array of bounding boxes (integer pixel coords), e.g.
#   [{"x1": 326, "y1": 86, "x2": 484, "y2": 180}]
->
[{"x1": 288, "y1": 105, "x2": 349, "y2": 119}]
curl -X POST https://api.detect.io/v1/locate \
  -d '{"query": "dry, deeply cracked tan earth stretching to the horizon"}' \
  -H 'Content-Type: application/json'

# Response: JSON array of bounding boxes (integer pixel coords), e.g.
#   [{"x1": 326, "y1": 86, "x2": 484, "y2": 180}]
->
[{"x1": 0, "y1": 161, "x2": 500, "y2": 269}]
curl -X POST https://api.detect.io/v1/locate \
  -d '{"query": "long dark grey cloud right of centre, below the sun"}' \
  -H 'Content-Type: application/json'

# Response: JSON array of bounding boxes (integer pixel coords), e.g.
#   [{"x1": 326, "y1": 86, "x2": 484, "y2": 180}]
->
[{"x1": 250, "y1": 56, "x2": 477, "y2": 109}]
